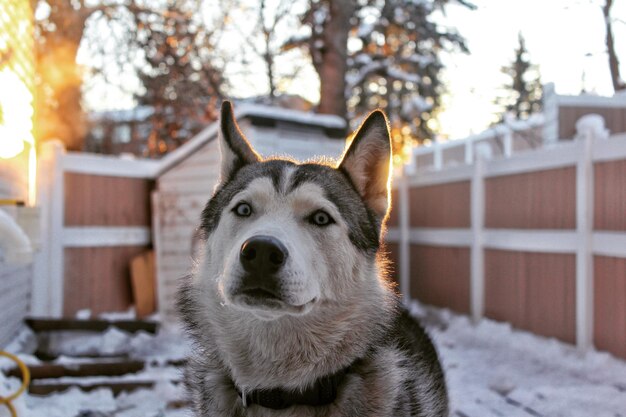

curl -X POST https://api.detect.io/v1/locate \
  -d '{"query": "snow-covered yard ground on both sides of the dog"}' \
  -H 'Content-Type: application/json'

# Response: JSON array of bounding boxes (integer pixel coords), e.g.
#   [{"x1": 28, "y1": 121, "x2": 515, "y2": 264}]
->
[{"x1": 0, "y1": 305, "x2": 626, "y2": 417}]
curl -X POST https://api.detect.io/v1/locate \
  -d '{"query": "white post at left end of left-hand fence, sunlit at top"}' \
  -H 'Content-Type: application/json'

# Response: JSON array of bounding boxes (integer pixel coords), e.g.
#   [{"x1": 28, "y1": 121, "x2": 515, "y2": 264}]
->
[{"x1": 31, "y1": 141, "x2": 65, "y2": 317}]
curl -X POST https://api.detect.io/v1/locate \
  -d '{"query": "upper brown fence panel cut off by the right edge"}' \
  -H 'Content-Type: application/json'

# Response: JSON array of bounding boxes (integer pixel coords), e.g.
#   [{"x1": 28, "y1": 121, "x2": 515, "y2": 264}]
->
[{"x1": 593, "y1": 161, "x2": 626, "y2": 231}]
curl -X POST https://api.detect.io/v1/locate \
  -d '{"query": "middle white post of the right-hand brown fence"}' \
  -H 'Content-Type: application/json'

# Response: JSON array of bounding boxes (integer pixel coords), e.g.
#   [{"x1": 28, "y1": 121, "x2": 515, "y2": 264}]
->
[{"x1": 470, "y1": 153, "x2": 485, "y2": 321}]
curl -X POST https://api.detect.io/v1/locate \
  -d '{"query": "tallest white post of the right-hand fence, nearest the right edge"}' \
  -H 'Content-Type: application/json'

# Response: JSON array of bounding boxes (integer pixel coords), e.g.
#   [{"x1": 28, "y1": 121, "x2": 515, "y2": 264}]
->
[{"x1": 576, "y1": 133, "x2": 594, "y2": 351}]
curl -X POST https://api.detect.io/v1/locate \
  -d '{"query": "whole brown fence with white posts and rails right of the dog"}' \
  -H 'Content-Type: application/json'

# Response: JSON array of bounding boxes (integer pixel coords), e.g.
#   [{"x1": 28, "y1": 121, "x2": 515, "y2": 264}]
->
[{"x1": 387, "y1": 135, "x2": 626, "y2": 357}]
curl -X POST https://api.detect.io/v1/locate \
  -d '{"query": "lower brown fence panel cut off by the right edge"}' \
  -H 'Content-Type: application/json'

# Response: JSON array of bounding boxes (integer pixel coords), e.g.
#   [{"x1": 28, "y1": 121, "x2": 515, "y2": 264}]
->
[{"x1": 593, "y1": 256, "x2": 626, "y2": 358}]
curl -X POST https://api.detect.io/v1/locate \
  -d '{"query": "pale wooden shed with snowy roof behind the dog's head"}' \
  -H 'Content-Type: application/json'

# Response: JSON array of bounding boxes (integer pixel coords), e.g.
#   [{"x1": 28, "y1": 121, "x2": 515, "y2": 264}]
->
[{"x1": 152, "y1": 105, "x2": 346, "y2": 321}]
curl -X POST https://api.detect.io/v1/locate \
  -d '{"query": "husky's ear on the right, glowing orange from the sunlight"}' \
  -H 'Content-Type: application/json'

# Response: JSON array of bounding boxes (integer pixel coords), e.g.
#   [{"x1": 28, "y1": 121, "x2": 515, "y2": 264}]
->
[{"x1": 338, "y1": 110, "x2": 391, "y2": 217}]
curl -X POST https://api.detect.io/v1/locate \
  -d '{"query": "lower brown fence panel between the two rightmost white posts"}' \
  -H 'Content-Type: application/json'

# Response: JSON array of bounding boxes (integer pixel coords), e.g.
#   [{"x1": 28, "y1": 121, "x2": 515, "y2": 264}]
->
[{"x1": 485, "y1": 249, "x2": 576, "y2": 343}]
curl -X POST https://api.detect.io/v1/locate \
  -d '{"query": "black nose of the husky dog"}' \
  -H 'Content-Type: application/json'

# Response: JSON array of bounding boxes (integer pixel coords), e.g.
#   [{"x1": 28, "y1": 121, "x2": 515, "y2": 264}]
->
[{"x1": 239, "y1": 236, "x2": 289, "y2": 275}]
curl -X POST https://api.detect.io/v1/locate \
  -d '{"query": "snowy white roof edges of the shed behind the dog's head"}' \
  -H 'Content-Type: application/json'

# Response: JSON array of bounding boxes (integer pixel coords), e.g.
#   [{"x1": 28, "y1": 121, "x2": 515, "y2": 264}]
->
[{"x1": 156, "y1": 103, "x2": 346, "y2": 177}]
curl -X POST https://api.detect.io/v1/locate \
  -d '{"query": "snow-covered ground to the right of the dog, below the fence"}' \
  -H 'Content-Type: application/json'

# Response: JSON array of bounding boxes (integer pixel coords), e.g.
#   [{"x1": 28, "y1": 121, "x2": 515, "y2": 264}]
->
[{"x1": 412, "y1": 304, "x2": 626, "y2": 417}]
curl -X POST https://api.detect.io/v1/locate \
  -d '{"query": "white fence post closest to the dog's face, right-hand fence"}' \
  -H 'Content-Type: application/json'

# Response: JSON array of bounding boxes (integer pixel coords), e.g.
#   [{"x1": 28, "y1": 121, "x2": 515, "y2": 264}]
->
[{"x1": 398, "y1": 167, "x2": 411, "y2": 305}]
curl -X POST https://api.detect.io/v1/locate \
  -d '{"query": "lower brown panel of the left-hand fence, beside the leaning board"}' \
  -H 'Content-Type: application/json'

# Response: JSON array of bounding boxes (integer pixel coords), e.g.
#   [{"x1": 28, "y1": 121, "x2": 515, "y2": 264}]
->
[{"x1": 63, "y1": 246, "x2": 147, "y2": 317}]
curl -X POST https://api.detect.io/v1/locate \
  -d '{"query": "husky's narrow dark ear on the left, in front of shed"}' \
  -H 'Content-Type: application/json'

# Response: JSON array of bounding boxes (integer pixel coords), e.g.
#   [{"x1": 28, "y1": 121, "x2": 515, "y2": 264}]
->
[{"x1": 218, "y1": 101, "x2": 261, "y2": 183}]
